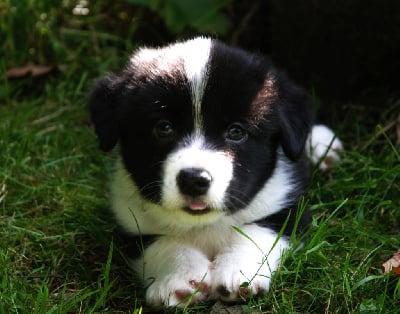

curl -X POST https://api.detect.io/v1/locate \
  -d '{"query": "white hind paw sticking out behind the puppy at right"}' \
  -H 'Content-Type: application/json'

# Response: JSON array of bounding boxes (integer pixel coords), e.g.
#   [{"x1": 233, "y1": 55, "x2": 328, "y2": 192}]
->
[{"x1": 306, "y1": 125, "x2": 343, "y2": 171}]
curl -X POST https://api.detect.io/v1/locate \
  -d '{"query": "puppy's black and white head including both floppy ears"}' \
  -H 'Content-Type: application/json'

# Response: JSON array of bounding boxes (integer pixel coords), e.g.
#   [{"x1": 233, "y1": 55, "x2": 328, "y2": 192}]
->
[{"x1": 90, "y1": 38, "x2": 310, "y2": 223}]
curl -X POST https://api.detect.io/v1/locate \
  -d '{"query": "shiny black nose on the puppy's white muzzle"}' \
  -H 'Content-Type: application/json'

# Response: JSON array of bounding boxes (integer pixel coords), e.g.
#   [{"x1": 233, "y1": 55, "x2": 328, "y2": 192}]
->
[{"x1": 176, "y1": 168, "x2": 212, "y2": 196}]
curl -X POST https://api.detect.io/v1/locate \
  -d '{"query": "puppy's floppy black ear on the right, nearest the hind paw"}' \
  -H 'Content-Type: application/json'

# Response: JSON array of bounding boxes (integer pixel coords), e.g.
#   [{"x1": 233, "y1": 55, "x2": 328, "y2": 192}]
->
[{"x1": 278, "y1": 79, "x2": 313, "y2": 160}]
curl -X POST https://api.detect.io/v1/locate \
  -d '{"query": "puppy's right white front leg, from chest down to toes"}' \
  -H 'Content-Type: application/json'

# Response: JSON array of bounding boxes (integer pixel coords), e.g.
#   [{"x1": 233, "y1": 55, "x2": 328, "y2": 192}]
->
[{"x1": 212, "y1": 224, "x2": 288, "y2": 301}]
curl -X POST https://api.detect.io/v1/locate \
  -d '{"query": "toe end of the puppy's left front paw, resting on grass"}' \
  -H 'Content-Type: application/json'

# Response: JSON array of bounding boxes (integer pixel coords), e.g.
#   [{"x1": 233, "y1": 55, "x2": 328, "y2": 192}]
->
[{"x1": 146, "y1": 273, "x2": 211, "y2": 307}]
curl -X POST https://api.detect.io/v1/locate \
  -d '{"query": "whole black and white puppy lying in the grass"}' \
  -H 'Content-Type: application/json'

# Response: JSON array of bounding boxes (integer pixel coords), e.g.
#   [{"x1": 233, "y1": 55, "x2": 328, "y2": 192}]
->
[{"x1": 90, "y1": 38, "x2": 341, "y2": 306}]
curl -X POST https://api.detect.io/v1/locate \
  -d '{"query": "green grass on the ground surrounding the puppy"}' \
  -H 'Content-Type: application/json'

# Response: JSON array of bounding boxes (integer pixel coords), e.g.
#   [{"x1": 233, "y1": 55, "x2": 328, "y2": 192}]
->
[{"x1": 0, "y1": 0, "x2": 400, "y2": 313}]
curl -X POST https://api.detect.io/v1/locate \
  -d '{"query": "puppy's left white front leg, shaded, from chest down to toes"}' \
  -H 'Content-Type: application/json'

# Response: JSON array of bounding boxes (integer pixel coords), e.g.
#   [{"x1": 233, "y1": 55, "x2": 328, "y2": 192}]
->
[{"x1": 134, "y1": 236, "x2": 211, "y2": 307}]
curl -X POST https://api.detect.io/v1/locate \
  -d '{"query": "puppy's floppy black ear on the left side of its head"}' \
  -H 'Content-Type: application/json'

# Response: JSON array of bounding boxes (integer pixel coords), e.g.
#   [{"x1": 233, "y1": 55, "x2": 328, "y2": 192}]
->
[{"x1": 89, "y1": 75, "x2": 123, "y2": 151}]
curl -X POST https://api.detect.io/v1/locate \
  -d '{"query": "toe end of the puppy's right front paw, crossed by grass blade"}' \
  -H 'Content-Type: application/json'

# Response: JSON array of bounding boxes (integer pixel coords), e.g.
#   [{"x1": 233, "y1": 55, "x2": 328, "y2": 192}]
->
[{"x1": 211, "y1": 253, "x2": 271, "y2": 301}]
